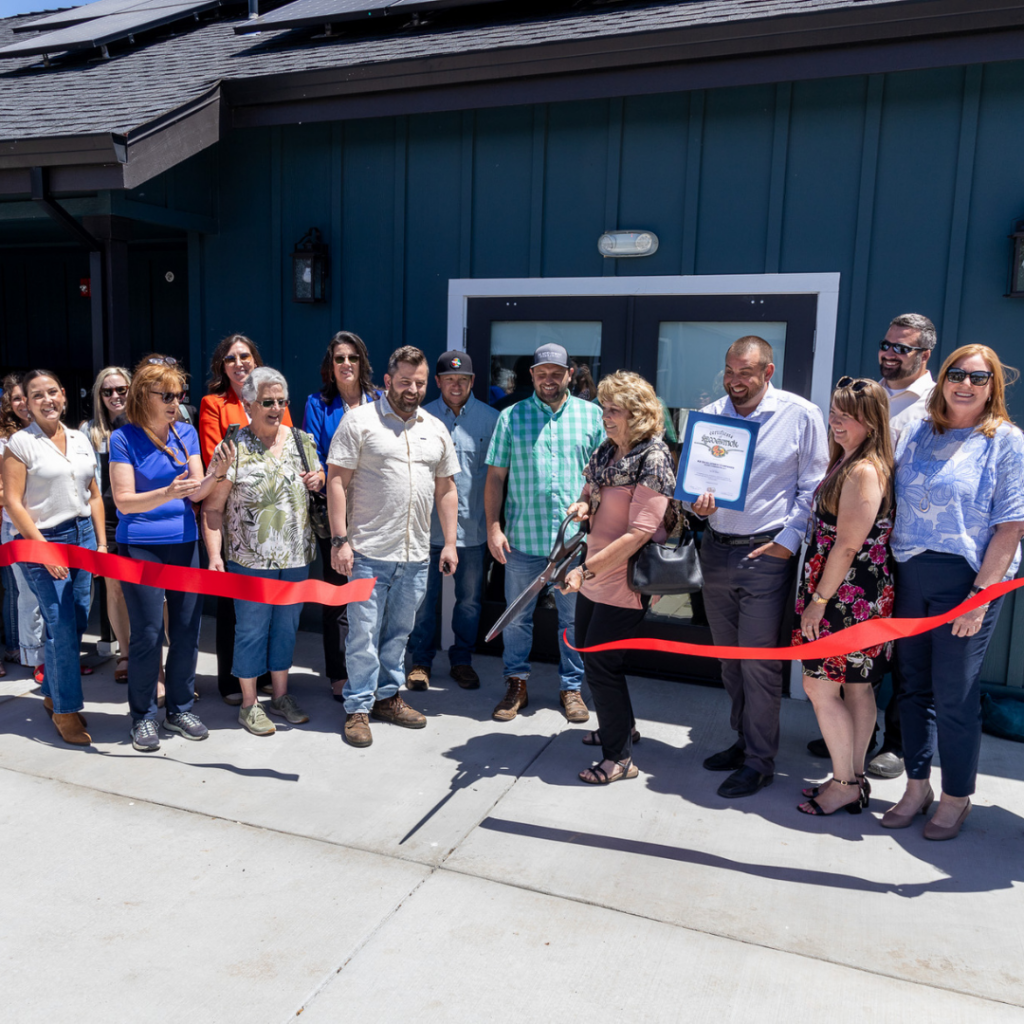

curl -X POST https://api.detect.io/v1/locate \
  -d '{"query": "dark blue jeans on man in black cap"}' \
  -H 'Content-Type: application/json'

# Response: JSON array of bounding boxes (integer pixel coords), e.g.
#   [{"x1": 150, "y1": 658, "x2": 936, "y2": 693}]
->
[{"x1": 409, "y1": 544, "x2": 487, "y2": 669}]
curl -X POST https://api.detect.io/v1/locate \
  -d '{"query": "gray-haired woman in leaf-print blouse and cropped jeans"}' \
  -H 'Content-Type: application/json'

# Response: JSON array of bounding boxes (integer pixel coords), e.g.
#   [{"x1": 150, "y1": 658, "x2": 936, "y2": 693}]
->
[{"x1": 203, "y1": 367, "x2": 324, "y2": 736}]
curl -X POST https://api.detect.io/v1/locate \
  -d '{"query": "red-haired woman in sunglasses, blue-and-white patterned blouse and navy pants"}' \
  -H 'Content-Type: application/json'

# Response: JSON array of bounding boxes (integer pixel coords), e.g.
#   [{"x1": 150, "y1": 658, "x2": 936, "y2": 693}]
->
[{"x1": 882, "y1": 345, "x2": 1024, "y2": 840}]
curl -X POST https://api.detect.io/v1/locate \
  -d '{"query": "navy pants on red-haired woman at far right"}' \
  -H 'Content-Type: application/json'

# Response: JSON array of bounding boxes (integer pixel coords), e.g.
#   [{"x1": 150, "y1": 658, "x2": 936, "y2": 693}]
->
[{"x1": 894, "y1": 551, "x2": 1002, "y2": 797}]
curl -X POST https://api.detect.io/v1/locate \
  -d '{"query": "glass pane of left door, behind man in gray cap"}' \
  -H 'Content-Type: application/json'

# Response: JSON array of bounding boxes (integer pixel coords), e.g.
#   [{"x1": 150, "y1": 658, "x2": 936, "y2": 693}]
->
[{"x1": 490, "y1": 321, "x2": 601, "y2": 398}]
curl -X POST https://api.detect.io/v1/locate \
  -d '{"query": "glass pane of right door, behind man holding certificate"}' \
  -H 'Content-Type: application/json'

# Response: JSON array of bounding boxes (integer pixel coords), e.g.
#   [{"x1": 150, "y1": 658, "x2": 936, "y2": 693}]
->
[{"x1": 648, "y1": 321, "x2": 786, "y2": 626}]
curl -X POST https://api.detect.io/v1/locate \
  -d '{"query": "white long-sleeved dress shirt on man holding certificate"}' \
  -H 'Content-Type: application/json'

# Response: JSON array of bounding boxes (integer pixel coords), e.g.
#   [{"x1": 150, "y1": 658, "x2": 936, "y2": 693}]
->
[{"x1": 701, "y1": 382, "x2": 828, "y2": 553}]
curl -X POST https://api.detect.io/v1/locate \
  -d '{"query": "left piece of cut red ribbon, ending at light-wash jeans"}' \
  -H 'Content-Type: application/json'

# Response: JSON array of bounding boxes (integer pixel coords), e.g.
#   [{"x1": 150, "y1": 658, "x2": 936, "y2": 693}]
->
[{"x1": 0, "y1": 541, "x2": 377, "y2": 606}]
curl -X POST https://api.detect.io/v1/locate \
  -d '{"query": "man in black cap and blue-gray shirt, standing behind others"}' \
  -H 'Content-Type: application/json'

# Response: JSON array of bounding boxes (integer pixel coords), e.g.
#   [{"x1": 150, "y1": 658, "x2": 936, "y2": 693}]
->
[{"x1": 406, "y1": 350, "x2": 498, "y2": 690}]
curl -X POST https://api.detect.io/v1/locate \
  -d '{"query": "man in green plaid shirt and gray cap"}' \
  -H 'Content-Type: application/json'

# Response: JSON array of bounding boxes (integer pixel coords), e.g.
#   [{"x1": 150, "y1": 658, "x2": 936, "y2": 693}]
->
[{"x1": 483, "y1": 345, "x2": 604, "y2": 722}]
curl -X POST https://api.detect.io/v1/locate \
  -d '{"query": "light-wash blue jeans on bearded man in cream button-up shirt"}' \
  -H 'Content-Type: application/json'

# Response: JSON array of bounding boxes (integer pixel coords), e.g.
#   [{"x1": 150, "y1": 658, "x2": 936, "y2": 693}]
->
[{"x1": 343, "y1": 552, "x2": 430, "y2": 715}]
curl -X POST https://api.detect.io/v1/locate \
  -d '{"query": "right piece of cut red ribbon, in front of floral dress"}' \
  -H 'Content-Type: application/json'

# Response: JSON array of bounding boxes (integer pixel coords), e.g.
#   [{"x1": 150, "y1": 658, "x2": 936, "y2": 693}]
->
[{"x1": 562, "y1": 580, "x2": 1024, "y2": 662}]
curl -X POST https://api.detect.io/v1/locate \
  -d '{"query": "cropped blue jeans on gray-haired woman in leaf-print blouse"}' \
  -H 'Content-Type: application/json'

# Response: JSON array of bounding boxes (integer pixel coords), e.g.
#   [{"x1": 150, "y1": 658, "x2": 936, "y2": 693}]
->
[{"x1": 227, "y1": 562, "x2": 309, "y2": 679}]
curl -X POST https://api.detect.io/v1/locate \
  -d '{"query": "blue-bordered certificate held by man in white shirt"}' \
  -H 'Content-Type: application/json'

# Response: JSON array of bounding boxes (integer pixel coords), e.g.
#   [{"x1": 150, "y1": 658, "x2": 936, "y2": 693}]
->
[{"x1": 676, "y1": 412, "x2": 760, "y2": 512}]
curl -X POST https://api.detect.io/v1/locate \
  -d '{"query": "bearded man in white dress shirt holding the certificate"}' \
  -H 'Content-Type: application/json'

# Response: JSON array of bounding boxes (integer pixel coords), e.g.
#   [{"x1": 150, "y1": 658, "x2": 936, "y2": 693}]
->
[{"x1": 693, "y1": 335, "x2": 828, "y2": 798}]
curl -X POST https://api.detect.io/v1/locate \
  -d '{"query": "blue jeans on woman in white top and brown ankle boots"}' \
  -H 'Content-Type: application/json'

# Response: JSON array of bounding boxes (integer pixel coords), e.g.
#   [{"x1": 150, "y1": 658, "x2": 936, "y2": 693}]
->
[{"x1": 22, "y1": 516, "x2": 96, "y2": 715}]
